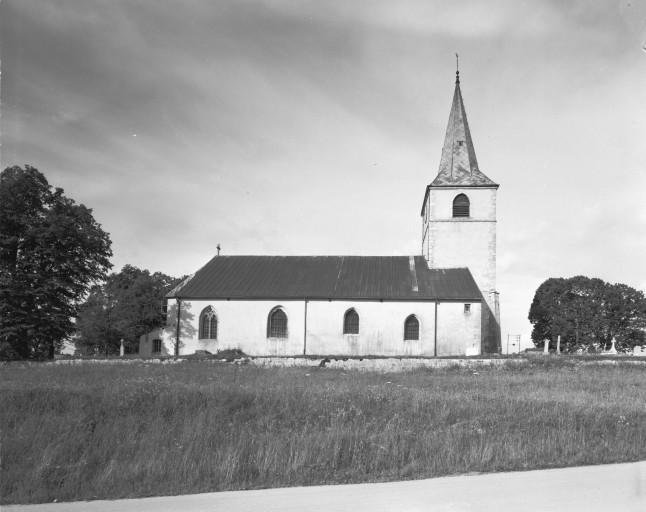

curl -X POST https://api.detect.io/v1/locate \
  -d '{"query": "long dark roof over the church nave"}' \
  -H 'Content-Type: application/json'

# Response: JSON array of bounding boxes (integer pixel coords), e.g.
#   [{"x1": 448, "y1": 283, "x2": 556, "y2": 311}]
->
[{"x1": 168, "y1": 256, "x2": 481, "y2": 302}]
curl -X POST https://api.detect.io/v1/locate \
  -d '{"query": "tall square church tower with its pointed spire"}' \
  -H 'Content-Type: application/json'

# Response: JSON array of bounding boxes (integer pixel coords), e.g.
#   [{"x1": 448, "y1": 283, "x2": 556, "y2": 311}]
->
[{"x1": 421, "y1": 62, "x2": 500, "y2": 353}]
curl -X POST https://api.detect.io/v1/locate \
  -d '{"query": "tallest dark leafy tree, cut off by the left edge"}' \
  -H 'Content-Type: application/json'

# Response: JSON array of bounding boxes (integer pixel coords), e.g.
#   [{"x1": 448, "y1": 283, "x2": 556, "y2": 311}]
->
[{"x1": 0, "y1": 166, "x2": 112, "y2": 358}]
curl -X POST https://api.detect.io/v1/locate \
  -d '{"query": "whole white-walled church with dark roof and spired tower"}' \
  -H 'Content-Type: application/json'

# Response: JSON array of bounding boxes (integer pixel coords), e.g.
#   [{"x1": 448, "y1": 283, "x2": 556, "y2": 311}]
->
[{"x1": 139, "y1": 72, "x2": 500, "y2": 357}]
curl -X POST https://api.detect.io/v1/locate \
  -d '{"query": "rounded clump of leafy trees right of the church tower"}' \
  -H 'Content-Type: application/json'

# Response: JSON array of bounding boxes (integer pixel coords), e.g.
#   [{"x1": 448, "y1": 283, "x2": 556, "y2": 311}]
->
[{"x1": 529, "y1": 276, "x2": 646, "y2": 349}]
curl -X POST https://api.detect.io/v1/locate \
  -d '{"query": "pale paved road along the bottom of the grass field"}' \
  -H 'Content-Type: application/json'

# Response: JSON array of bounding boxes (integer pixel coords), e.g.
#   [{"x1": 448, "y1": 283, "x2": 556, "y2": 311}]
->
[{"x1": 2, "y1": 462, "x2": 646, "y2": 512}]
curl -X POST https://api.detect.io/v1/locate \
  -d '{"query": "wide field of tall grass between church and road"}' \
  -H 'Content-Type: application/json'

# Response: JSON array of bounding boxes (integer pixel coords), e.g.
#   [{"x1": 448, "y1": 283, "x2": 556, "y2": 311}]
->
[{"x1": 0, "y1": 358, "x2": 646, "y2": 503}]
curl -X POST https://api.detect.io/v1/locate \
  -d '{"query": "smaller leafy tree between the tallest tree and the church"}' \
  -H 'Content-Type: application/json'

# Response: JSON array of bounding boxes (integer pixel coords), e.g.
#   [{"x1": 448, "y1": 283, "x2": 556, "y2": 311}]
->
[{"x1": 76, "y1": 265, "x2": 181, "y2": 354}]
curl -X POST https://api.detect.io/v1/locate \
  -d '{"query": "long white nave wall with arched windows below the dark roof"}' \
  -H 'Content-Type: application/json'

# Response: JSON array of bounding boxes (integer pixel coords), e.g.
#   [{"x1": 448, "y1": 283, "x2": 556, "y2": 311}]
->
[{"x1": 148, "y1": 300, "x2": 481, "y2": 356}]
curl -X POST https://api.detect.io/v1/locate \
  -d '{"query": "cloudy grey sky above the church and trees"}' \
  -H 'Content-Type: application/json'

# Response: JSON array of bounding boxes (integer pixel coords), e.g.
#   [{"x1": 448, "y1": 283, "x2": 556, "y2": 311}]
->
[{"x1": 0, "y1": 0, "x2": 646, "y2": 349}]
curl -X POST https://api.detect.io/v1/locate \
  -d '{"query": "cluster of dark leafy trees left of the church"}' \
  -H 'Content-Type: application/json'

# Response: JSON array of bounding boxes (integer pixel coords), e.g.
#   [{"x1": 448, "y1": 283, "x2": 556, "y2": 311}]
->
[{"x1": 0, "y1": 166, "x2": 179, "y2": 360}]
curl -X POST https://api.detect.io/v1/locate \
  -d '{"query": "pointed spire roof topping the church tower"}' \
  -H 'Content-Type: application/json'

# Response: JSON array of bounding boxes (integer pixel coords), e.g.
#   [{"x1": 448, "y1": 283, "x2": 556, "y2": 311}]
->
[{"x1": 430, "y1": 71, "x2": 498, "y2": 187}]
